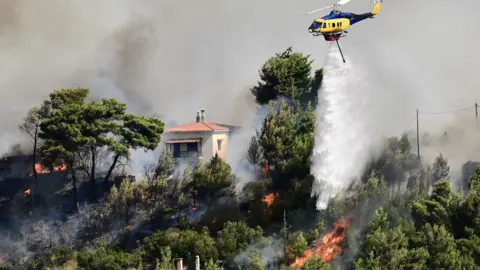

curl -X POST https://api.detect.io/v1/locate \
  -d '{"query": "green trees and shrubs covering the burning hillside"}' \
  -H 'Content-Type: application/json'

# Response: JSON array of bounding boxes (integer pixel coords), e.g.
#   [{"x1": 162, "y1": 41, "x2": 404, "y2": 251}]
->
[{"x1": 0, "y1": 48, "x2": 480, "y2": 270}]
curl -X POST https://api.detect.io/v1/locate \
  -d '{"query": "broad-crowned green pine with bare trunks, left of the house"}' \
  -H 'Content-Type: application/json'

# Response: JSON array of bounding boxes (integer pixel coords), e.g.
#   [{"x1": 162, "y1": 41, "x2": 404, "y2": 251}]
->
[{"x1": 39, "y1": 89, "x2": 164, "y2": 204}]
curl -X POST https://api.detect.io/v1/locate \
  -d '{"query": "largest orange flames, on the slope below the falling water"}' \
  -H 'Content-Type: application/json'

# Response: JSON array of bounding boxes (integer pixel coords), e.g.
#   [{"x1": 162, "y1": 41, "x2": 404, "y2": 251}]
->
[{"x1": 291, "y1": 219, "x2": 352, "y2": 269}]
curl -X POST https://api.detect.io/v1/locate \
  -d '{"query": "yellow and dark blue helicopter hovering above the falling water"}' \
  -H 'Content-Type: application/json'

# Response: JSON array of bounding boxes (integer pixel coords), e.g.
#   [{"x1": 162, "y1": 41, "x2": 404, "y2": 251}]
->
[{"x1": 307, "y1": 0, "x2": 383, "y2": 63}]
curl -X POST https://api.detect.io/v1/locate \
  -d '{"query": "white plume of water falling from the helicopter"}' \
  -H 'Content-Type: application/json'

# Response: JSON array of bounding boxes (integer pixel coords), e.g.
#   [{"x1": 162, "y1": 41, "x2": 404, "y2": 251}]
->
[{"x1": 312, "y1": 42, "x2": 371, "y2": 209}]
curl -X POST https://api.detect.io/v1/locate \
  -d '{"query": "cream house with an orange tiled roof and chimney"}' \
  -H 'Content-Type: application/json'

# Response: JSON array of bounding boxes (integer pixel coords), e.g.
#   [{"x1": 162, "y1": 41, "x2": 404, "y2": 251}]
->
[{"x1": 164, "y1": 109, "x2": 239, "y2": 167}]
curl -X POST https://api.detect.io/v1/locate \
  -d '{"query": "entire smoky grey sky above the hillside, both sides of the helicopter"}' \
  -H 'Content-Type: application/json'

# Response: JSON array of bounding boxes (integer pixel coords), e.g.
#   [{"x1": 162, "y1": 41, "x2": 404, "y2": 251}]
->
[{"x1": 0, "y1": 0, "x2": 480, "y2": 166}]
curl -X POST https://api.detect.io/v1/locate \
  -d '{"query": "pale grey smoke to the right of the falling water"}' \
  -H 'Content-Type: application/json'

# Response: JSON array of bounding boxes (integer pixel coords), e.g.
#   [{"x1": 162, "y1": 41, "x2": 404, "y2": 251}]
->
[{"x1": 341, "y1": 0, "x2": 480, "y2": 173}]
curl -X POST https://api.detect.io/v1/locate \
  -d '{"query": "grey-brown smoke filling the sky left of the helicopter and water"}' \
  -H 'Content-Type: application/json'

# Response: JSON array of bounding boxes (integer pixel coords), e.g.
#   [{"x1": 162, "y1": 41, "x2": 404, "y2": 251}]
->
[{"x1": 0, "y1": 0, "x2": 330, "y2": 173}]
